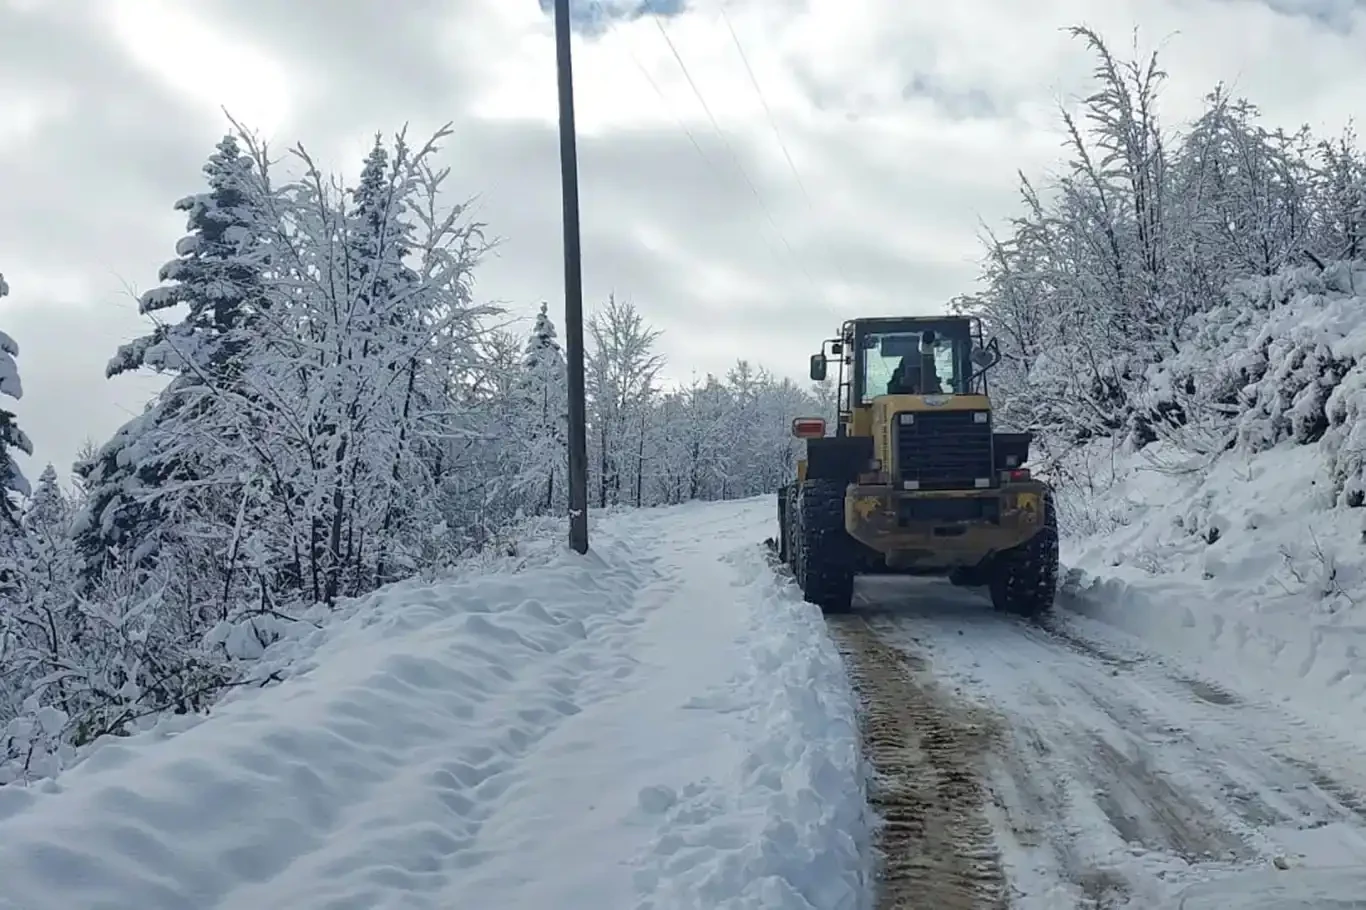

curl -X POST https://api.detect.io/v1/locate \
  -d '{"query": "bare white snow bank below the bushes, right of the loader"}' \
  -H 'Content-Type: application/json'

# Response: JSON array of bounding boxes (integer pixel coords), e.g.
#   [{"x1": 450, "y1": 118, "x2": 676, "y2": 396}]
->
[{"x1": 1061, "y1": 443, "x2": 1366, "y2": 748}]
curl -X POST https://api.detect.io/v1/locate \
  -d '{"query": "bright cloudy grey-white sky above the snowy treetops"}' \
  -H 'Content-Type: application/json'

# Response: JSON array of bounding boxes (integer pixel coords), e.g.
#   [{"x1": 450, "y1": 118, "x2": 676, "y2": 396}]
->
[{"x1": 0, "y1": 0, "x2": 1366, "y2": 477}]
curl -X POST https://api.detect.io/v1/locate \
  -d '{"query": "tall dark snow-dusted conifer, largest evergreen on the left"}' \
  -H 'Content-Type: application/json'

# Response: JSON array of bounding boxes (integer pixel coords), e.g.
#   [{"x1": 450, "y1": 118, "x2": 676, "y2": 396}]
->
[{"x1": 72, "y1": 135, "x2": 265, "y2": 582}]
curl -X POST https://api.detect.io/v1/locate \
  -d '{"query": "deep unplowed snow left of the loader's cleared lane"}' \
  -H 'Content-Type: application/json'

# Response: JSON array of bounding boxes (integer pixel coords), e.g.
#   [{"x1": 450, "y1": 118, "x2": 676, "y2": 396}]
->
[{"x1": 0, "y1": 499, "x2": 870, "y2": 910}]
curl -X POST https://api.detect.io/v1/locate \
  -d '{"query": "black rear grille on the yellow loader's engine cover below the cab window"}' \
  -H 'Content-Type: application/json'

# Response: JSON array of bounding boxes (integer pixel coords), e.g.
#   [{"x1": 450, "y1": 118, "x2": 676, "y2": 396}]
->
[{"x1": 895, "y1": 411, "x2": 996, "y2": 489}]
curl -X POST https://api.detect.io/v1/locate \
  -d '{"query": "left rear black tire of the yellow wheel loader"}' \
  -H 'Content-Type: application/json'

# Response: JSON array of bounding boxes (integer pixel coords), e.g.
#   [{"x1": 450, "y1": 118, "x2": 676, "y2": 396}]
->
[{"x1": 791, "y1": 480, "x2": 854, "y2": 613}]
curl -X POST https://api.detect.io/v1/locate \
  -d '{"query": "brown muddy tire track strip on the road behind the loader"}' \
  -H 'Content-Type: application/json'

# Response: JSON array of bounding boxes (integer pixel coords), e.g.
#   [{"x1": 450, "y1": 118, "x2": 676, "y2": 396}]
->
[{"x1": 829, "y1": 616, "x2": 1009, "y2": 910}]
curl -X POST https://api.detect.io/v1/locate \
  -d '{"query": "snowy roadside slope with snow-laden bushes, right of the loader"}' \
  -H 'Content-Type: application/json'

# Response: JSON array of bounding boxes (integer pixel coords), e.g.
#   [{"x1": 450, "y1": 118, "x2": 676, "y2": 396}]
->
[{"x1": 1061, "y1": 264, "x2": 1366, "y2": 736}]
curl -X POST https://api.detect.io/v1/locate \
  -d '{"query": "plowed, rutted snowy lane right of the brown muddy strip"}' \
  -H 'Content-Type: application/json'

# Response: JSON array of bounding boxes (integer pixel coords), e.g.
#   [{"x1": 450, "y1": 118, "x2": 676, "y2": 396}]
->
[{"x1": 854, "y1": 582, "x2": 1366, "y2": 910}]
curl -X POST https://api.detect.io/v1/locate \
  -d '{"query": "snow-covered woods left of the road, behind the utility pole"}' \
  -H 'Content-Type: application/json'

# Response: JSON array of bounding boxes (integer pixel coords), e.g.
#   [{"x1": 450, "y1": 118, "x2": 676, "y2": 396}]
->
[{"x1": 0, "y1": 120, "x2": 820, "y2": 783}]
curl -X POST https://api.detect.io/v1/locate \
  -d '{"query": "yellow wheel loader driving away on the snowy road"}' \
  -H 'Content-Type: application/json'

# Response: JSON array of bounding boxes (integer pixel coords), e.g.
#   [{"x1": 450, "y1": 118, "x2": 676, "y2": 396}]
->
[{"x1": 777, "y1": 316, "x2": 1057, "y2": 616}]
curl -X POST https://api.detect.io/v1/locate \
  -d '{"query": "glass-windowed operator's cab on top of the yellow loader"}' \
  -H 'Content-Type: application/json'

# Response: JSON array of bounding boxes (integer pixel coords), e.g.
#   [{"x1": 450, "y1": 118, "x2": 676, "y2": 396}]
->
[{"x1": 810, "y1": 317, "x2": 1001, "y2": 436}]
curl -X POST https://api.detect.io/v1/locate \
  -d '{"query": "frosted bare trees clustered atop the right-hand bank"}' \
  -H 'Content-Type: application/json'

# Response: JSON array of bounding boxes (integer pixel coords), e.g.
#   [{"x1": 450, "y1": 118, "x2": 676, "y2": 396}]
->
[{"x1": 955, "y1": 19, "x2": 1366, "y2": 504}]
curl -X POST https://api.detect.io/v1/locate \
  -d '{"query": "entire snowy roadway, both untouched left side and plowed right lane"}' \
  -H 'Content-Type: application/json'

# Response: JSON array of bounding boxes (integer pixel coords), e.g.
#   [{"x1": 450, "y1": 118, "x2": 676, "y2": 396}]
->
[{"x1": 13, "y1": 497, "x2": 1366, "y2": 910}]
